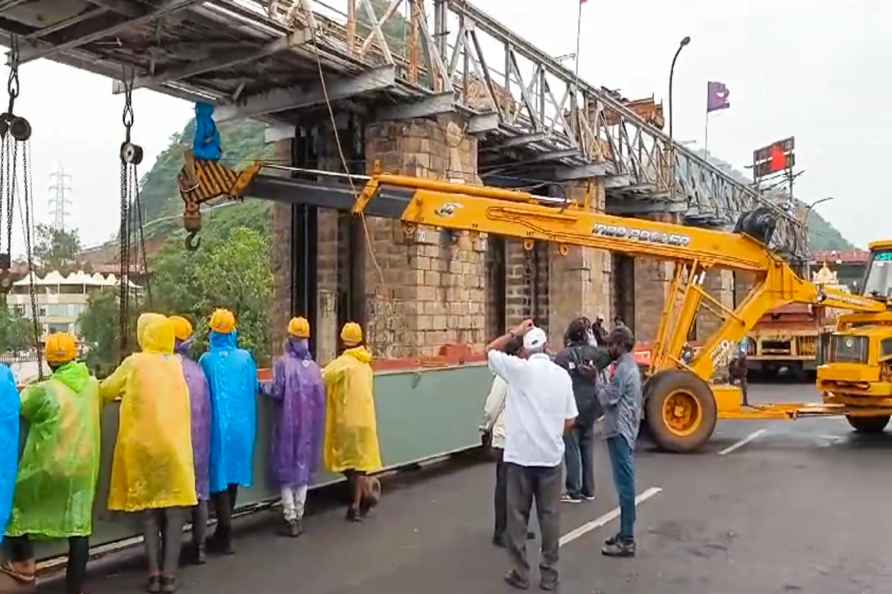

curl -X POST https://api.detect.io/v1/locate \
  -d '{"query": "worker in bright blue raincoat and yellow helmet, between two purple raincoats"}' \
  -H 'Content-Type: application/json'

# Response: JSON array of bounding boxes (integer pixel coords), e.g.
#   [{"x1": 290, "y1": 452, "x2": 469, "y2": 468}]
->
[{"x1": 199, "y1": 309, "x2": 260, "y2": 555}]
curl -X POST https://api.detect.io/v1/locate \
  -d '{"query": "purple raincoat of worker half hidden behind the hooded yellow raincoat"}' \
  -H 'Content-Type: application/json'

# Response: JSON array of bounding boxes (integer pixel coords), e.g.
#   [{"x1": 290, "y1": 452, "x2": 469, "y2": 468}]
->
[{"x1": 176, "y1": 340, "x2": 211, "y2": 501}]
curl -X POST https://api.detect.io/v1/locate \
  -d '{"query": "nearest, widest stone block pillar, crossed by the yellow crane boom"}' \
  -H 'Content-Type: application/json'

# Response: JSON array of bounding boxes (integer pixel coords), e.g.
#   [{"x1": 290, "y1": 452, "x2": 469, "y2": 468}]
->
[{"x1": 363, "y1": 115, "x2": 487, "y2": 357}]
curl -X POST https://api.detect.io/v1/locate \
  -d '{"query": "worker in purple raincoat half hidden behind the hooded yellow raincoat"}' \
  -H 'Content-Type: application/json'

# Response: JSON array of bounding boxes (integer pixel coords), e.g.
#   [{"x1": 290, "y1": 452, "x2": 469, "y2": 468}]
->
[{"x1": 169, "y1": 316, "x2": 211, "y2": 565}]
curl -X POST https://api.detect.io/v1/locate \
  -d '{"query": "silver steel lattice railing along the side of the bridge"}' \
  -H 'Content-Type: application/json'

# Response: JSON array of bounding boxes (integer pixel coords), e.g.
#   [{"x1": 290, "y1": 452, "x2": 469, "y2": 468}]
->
[{"x1": 270, "y1": 0, "x2": 805, "y2": 256}]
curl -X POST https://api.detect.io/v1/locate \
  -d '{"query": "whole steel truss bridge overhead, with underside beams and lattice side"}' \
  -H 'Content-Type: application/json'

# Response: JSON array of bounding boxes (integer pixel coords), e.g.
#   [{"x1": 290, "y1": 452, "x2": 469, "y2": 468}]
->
[{"x1": 0, "y1": 0, "x2": 805, "y2": 256}]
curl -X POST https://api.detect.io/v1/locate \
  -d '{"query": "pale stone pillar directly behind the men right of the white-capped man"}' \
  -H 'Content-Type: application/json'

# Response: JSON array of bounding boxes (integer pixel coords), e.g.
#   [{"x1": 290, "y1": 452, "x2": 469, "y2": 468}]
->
[{"x1": 548, "y1": 180, "x2": 611, "y2": 349}]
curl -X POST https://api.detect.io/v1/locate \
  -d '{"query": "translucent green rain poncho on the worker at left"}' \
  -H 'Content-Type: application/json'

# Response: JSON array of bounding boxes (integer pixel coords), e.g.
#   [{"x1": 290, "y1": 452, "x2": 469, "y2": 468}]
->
[{"x1": 7, "y1": 362, "x2": 101, "y2": 538}]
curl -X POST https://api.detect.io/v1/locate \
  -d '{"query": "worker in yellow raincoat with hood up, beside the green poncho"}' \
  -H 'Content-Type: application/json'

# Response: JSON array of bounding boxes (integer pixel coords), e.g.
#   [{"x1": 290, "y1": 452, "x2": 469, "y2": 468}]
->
[{"x1": 100, "y1": 313, "x2": 198, "y2": 592}]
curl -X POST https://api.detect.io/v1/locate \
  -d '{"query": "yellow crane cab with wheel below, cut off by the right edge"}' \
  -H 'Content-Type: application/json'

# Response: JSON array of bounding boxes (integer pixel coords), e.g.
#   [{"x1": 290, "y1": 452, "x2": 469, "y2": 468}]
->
[{"x1": 817, "y1": 241, "x2": 892, "y2": 432}]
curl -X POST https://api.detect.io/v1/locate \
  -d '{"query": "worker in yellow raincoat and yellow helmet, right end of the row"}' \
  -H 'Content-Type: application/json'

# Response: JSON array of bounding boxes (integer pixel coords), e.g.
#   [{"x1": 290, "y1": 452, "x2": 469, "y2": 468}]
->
[{"x1": 322, "y1": 322, "x2": 381, "y2": 522}]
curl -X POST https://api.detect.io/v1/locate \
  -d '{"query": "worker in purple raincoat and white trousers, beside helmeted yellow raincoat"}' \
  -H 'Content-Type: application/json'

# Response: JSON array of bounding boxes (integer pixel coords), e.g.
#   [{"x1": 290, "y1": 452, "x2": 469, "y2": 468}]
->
[{"x1": 263, "y1": 318, "x2": 325, "y2": 537}]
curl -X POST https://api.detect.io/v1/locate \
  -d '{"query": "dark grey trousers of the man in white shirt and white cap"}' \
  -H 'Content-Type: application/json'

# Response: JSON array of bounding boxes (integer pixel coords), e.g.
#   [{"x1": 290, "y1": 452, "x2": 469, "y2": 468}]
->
[{"x1": 506, "y1": 462, "x2": 561, "y2": 581}]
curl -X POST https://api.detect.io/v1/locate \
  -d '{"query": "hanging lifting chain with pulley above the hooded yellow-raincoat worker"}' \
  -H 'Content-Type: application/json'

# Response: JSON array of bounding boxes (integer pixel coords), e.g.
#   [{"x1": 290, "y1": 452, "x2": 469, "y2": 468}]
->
[{"x1": 118, "y1": 72, "x2": 152, "y2": 359}]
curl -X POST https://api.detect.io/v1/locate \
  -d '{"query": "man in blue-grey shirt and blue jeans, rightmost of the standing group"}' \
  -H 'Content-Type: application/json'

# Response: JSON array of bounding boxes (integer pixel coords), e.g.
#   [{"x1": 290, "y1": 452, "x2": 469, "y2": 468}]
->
[{"x1": 595, "y1": 326, "x2": 641, "y2": 557}]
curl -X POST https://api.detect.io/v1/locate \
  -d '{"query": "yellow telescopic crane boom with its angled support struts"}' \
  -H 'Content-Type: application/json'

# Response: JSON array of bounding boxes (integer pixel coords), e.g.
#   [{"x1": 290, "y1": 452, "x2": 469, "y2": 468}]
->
[{"x1": 353, "y1": 174, "x2": 884, "y2": 381}]
